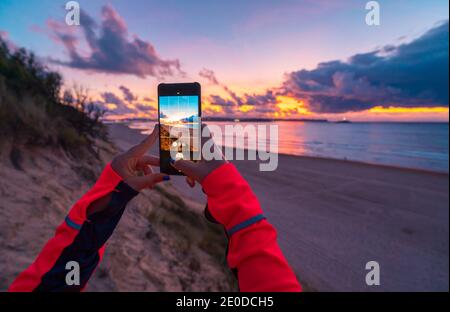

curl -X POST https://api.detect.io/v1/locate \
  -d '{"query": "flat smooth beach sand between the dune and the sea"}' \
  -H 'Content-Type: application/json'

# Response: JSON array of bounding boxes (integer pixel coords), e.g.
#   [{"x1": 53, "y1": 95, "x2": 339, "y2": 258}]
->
[{"x1": 109, "y1": 124, "x2": 449, "y2": 291}]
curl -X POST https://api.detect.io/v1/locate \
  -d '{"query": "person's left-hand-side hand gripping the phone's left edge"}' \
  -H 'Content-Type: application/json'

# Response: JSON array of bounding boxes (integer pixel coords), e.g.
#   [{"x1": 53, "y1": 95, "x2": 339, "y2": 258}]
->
[{"x1": 111, "y1": 126, "x2": 170, "y2": 192}]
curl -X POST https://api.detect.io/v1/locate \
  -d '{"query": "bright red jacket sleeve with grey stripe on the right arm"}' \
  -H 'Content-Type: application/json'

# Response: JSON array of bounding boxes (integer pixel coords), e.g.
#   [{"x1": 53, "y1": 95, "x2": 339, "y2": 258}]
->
[{"x1": 202, "y1": 163, "x2": 301, "y2": 292}]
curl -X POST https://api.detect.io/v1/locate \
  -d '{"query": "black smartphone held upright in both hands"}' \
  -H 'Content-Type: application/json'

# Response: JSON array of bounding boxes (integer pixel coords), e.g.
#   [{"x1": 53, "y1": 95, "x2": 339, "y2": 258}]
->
[{"x1": 158, "y1": 82, "x2": 201, "y2": 175}]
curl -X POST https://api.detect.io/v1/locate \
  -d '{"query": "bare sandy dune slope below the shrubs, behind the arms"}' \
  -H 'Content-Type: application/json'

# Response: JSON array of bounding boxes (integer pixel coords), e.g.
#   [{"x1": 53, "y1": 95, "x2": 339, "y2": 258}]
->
[{"x1": 0, "y1": 135, "x2": 236, "y2": 291}]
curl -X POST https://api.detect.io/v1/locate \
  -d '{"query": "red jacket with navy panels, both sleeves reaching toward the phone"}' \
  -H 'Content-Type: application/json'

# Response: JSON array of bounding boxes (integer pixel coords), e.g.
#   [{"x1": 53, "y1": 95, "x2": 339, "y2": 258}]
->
[{"x1": 9, "y1": 164, "x2": 301, "y2": 291}]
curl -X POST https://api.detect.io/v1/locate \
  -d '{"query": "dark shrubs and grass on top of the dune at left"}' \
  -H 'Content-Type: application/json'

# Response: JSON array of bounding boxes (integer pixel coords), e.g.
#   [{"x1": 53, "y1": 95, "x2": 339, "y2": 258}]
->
[{"x1": 0, "y1": 38, "x2": 107, "y2": 151}]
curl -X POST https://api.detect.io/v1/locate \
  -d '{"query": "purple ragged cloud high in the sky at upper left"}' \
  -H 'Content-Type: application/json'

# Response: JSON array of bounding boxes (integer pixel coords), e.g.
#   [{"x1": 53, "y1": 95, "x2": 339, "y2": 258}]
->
[{"x1": 48, "y1": 5, "x2": 183, "y2": 78}]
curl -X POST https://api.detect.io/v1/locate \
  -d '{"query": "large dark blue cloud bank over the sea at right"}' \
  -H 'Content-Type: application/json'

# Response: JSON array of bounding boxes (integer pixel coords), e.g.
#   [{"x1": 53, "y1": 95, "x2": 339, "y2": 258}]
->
[{"x1": 282, "y1": 21, "x2": 449, "y2": 113}]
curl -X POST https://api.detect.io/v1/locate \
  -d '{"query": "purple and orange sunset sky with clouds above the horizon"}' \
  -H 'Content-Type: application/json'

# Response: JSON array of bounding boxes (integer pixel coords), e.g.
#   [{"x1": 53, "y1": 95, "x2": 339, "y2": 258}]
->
[{"x1": 0, "y1": 0, "x2": 449, "y2": 121}]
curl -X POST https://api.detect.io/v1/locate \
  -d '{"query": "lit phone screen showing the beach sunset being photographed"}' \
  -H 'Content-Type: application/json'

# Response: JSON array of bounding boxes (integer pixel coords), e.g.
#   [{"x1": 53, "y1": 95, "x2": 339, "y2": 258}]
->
[{"x1": 159, "y1": 95, "x2": 200, "y2": 175}]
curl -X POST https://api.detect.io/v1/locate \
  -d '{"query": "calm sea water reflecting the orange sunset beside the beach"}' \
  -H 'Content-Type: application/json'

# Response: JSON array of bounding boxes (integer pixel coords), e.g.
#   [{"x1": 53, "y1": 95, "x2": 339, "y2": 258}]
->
[{"x1": 130, "y1": 121, "x2": 449, "y2": 172}]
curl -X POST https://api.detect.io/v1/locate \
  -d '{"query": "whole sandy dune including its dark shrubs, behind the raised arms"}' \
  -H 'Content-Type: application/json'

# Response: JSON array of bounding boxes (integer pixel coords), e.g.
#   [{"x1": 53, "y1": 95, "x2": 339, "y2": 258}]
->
[{"x1": 0, "y1": 38, "x2": 237, "y2": 291}]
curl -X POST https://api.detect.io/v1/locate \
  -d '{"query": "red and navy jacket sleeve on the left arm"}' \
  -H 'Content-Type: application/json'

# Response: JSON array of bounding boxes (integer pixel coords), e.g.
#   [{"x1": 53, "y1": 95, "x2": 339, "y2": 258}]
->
[{"x1": 9, "y1": 164, "x2": 137, "y2": 292}]
